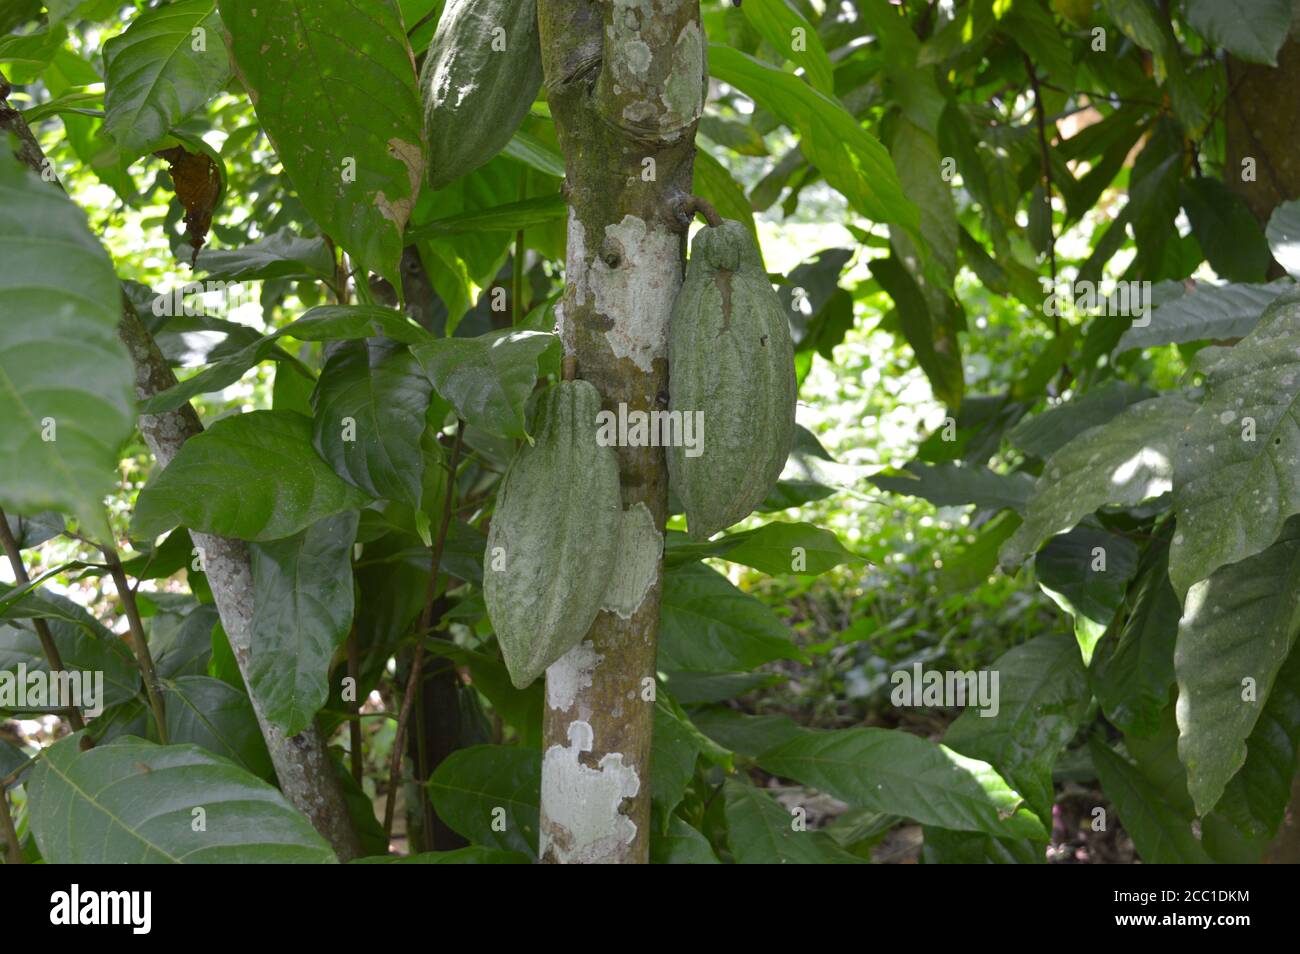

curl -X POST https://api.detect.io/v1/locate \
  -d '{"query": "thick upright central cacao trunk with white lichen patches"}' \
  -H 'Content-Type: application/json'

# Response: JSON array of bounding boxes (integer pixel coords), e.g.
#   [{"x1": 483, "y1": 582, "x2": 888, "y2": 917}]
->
[{"x1": 538, "y1": 0, "x2": 706, "y2": 863}]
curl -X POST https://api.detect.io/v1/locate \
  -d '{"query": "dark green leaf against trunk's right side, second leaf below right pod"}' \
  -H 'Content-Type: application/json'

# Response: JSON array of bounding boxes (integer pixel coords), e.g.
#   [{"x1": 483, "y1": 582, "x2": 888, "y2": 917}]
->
[{"x1": 659, "y1": 563, "x2": 800, "y2": 672}]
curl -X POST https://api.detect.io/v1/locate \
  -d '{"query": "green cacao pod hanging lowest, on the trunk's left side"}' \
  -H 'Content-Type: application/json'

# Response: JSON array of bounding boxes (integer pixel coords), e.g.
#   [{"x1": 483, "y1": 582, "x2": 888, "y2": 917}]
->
[{"x1": 484, "y1": 381, "x2": 623, "y2": 689}]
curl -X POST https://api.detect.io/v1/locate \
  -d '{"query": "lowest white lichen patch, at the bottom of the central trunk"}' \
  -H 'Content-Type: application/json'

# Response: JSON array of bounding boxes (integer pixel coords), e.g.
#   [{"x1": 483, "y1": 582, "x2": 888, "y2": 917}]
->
[{"x1": 541, "y1": 720, "x2": 641, "y2": 864}]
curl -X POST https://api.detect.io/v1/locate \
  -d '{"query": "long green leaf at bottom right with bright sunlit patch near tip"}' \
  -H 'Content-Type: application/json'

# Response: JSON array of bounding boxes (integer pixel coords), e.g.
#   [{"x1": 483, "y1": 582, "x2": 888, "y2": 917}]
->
[{"x1": 758, "y1": 729, "x2": 1047, "y2": 838}]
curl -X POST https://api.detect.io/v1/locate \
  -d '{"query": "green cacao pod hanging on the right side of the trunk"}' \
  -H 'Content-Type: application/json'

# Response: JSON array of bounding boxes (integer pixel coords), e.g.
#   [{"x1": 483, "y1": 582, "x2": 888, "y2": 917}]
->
[{"x1": 667, "y1": 220, "x2": 796, "y2": 539}]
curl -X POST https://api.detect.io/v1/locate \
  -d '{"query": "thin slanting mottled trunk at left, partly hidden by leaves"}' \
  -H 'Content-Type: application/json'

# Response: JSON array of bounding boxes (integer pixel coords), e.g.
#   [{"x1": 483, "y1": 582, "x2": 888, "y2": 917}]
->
[{"x1": 0, "y1": 75, "x2": 361, "y2": 862}]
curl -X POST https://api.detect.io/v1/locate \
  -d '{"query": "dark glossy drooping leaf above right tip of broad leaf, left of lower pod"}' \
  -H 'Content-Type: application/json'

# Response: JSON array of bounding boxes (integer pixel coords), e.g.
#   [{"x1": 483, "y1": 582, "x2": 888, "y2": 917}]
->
[{"x1": 312, "y1": 339, "x2": 433, "y2": 507}]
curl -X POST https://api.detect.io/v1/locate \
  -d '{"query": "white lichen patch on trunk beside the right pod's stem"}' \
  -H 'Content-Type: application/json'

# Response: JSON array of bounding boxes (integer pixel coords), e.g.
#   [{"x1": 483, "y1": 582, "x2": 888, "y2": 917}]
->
[{"x1": 590, "y1": 216, "x2": 681, "y2": 372}]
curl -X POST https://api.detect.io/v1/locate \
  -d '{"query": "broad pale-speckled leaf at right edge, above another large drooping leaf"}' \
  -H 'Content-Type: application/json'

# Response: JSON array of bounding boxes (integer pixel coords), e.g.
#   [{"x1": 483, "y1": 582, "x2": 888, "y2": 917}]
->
[{"x1": 1175, "y1": 292, "x2": 1300, "y2": 597}]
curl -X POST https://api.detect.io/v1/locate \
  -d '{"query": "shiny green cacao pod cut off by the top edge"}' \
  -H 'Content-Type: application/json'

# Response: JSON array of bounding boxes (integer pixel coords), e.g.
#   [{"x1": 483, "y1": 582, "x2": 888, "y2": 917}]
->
[{"x1": 420, "y1": 0, "x2": 542, "y2": 188}]
